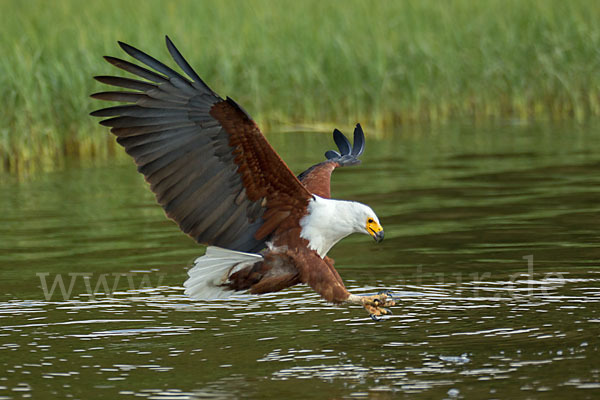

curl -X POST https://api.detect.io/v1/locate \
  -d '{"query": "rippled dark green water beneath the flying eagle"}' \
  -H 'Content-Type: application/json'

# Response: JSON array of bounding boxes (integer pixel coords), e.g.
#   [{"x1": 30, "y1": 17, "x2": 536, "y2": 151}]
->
[{"x1": 0, "y1": 122, "x2": 600, "y2": 399}]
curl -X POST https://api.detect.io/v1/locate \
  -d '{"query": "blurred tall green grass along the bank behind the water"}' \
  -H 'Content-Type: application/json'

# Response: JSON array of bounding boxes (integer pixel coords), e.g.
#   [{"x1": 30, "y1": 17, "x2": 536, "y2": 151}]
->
[{"x1": 0, "y1": 0, "x2": 600, "y2": 170}]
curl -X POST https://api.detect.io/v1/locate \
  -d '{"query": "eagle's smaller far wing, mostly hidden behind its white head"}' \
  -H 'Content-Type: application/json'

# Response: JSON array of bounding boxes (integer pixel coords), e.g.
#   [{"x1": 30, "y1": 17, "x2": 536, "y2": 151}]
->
[{"x1": 298, "y1": 124, "x2": 365, "y2": 198}]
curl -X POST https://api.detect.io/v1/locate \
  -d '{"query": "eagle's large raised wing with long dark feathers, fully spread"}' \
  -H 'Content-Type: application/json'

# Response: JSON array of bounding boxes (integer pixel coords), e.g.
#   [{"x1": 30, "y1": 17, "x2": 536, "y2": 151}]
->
[{"x1": 91, "y1": 37, "x2": 311, "y2": 251}]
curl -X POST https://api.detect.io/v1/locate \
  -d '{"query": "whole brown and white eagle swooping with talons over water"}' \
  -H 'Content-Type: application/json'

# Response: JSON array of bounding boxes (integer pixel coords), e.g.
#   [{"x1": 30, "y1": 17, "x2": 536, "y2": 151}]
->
[{"x1": 91, "y1": 37, "x2": 394, "y2": 320}]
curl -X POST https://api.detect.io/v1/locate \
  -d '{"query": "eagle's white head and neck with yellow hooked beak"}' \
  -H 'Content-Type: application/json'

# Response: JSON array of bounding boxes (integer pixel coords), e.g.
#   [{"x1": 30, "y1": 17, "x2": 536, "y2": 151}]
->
[{"x1": 300, "y1": 195, "x2": 383, "y2": 257}]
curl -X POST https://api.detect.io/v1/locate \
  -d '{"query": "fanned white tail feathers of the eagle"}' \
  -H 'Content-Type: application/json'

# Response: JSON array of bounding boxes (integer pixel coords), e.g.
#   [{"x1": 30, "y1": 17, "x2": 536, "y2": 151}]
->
[{"x1": 183, "y1": 246, "x2": 263, "y2": 300}]
